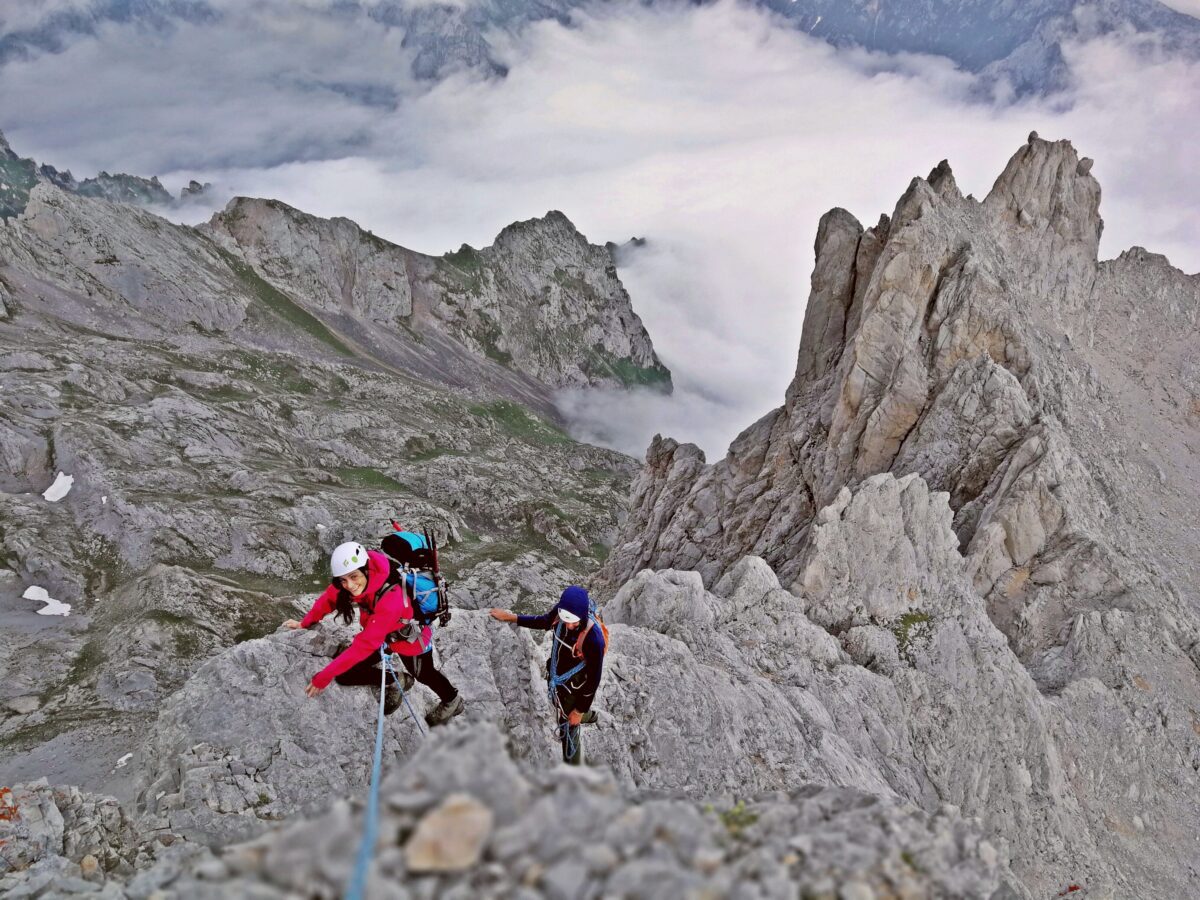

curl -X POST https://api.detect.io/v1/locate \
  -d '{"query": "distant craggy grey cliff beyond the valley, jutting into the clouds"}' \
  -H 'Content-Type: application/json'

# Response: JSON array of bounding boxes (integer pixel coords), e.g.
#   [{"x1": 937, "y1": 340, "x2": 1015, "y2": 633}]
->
[{"x1": 202, "y1": 198, "x2": 671, "y2": 390}]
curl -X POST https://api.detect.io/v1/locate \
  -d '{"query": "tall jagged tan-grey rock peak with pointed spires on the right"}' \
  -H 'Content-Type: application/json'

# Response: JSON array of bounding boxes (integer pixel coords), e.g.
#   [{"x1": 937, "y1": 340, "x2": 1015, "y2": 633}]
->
[{"x1": 602, "y1": 136, "x2": 1200, "y2": 893}]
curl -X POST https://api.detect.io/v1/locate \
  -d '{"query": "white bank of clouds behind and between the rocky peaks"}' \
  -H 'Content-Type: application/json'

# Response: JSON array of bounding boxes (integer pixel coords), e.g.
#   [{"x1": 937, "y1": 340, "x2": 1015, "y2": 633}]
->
[{"x1": 0, "y1": 0, "x2": 1200, "y2": 458}]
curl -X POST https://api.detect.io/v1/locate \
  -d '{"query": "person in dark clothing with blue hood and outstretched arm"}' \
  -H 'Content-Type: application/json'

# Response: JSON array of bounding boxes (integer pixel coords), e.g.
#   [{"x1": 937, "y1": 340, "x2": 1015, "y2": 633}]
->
[{"x1": 491, "y1": 584, "x2": 607, "y2": 766}]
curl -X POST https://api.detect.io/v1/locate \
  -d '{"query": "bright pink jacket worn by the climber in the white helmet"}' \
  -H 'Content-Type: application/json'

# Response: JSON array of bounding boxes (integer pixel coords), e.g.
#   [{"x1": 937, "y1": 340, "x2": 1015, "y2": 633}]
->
[{"x1": 300, "y1": 550, "x2": 433, "y2": 688}]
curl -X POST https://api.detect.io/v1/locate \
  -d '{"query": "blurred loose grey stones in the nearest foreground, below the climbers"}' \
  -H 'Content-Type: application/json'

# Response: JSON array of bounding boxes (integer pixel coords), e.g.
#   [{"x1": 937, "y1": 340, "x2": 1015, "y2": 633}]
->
[{"x1": 0, "y1": 725, "x2": 1019, "y2": 900}]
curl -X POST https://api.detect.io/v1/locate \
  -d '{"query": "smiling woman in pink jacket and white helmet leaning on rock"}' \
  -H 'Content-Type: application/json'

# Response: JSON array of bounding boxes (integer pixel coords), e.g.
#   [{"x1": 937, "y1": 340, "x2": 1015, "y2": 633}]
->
[{"x1": 283, "y1": 541, "x2": 463, "y2": 725}]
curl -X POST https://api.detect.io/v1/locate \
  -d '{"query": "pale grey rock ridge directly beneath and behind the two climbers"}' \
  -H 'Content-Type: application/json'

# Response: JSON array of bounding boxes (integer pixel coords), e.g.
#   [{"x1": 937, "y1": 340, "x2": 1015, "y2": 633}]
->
[{"x1": 0, "y1": 475, "x2": 1099, "y2": 896}]
